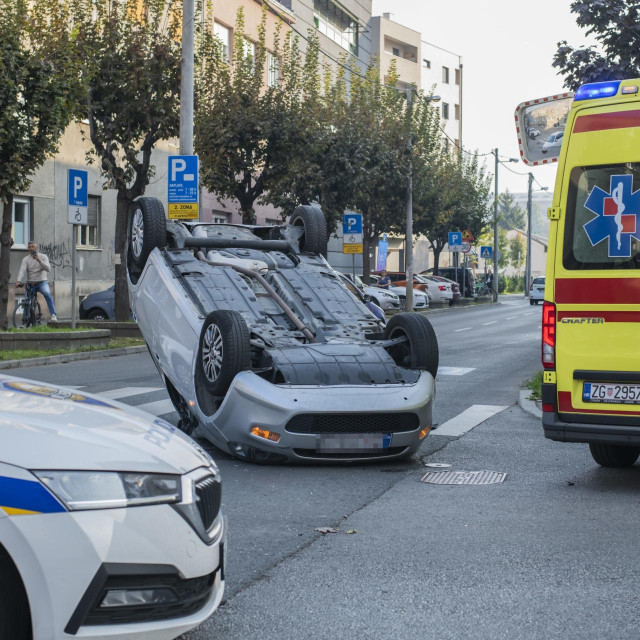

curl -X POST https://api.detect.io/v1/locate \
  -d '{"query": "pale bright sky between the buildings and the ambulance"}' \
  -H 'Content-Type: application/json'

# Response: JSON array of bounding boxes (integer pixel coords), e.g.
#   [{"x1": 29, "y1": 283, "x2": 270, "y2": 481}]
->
[{"x1": 372, "y1": 0, "x2": 586, "y2": 193}]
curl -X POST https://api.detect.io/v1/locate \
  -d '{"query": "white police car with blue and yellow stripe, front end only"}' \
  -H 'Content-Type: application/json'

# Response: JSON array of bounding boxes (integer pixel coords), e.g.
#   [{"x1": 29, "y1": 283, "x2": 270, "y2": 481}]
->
[{"x1": 0, "y1": 375, "x2": 225, "y2": 640}]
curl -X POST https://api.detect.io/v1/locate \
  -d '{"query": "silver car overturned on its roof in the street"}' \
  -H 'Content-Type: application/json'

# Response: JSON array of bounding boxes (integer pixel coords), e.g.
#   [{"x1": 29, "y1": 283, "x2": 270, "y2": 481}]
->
[{"x1": 127, "y1": 198, "x2": 438, "y2": 462}]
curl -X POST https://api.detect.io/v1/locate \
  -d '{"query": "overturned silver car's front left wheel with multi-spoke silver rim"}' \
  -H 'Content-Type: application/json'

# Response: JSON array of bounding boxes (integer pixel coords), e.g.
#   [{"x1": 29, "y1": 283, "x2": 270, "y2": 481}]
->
[{"x1": 196, "y1": 310, "x2": 251, "y2": 396}]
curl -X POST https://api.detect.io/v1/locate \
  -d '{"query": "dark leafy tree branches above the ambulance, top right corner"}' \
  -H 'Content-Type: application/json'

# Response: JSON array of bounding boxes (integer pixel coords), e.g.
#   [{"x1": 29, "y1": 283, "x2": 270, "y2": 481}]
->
[{"x1": 553, "y1": 0, "x2": 640, "y2": 91}]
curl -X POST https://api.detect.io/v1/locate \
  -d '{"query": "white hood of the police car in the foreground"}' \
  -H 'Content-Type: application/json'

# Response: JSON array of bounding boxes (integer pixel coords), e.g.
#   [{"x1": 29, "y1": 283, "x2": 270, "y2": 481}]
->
[{"x1": 0, "y1": 376, "x2": 212, "y2": 474}]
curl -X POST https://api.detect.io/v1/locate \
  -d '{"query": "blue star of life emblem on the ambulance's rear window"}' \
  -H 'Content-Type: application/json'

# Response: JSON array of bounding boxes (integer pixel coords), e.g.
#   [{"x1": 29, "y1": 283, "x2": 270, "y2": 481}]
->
[{"x1": 584, "y1": 175, "x2": 640, "y2": 258}]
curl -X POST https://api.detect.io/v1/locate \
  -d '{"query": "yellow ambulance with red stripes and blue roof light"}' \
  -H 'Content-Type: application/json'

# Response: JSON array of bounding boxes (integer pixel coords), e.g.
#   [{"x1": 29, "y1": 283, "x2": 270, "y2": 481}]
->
[{"x1": 516, "y1": 79, "x2": 640, "y2": 467}]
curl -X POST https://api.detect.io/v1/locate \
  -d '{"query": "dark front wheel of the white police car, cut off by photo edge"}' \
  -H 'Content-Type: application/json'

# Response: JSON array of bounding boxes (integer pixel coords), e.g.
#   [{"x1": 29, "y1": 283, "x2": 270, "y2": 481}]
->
[{"x1": 0, "y1": 547, "x2": 32, "y2": 640}]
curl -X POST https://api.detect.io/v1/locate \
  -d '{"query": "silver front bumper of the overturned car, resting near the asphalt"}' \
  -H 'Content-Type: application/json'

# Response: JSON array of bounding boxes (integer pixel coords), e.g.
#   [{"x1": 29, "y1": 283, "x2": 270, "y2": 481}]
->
[{"x1": 200, "y1": 371, "x2": 435, "y2": 462}]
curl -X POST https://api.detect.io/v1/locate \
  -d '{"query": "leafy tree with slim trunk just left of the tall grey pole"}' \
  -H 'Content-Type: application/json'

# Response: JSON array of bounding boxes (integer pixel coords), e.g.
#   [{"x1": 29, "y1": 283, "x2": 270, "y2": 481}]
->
[{"x1": 78, "y1": 0, "x2": 182, "y2": 321}]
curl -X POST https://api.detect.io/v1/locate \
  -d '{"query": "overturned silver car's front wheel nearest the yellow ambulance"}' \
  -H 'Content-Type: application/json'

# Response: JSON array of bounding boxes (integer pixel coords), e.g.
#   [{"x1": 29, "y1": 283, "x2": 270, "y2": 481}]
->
[{"x1": 384, "y1": 313, "x2": 440, "y2": 378}]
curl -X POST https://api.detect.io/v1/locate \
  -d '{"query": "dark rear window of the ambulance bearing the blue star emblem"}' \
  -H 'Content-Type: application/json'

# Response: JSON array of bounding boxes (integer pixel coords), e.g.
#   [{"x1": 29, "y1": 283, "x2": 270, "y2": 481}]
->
[{"x1": 563, "y1": 163, "x2": 640, "y2": 269}]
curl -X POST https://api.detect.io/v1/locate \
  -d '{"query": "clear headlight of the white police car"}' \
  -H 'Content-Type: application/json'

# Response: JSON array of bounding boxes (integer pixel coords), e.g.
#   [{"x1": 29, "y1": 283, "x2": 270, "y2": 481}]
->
[{"x1": 34, "y1": 471, "x2": 182, "y2": 511}]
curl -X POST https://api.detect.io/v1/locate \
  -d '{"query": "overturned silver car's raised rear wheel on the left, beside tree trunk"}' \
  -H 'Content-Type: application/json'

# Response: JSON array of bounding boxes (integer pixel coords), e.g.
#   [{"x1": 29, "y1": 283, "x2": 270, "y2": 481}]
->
[{"x1": 127, "y1": 197, "x2": 167, "y2": 271}]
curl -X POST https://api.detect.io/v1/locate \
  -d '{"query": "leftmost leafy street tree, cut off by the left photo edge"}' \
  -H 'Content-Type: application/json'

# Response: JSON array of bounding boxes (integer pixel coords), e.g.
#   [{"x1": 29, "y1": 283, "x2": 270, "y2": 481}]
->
[{"x1": 0, "y1": 0, "x2": 82, "y2": 329}]
